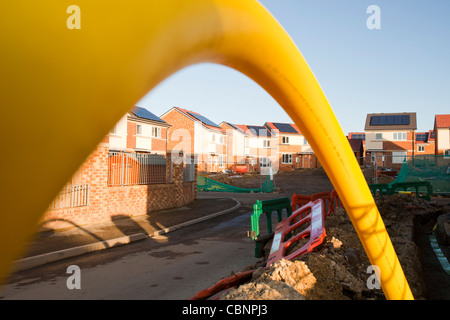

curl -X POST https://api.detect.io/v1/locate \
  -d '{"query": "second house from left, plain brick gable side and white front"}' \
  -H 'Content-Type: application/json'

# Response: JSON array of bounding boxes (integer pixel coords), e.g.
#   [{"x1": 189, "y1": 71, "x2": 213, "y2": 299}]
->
[{"x1": 161, "y1": 107, "x2": 227, "y2": 172}]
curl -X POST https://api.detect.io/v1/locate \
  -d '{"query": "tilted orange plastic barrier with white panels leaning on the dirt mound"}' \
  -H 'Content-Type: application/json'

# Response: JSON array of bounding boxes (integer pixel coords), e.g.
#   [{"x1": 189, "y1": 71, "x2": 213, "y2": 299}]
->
[{"x1": 266, "y1": 199, "x2": 326, "y2": 267}]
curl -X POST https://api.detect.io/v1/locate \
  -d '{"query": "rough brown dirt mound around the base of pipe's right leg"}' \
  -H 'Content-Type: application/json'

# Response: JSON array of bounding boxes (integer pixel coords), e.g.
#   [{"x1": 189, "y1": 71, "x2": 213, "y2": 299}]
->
[{"x1": 221, "y1": 194, "x2": 437, "y2": 300}]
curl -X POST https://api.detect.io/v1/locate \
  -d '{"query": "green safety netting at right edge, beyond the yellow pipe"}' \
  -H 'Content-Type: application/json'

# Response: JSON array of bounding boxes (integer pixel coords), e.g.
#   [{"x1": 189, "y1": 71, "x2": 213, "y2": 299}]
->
[{"x1": 389, "y1": 155, "x2": 450, "y2": 194}]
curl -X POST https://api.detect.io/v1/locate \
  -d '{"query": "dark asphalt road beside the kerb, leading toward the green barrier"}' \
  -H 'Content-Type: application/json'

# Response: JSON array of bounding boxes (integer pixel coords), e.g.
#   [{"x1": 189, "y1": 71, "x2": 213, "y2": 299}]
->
[{"x1": 0, "y1": 207, "x2": 258, "y2": 300}]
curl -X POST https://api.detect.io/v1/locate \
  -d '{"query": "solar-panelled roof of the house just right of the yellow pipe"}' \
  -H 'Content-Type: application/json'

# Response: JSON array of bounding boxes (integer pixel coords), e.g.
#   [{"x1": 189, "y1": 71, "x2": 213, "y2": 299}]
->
[{"x1": 364, "y1": 112, "x2": 417, "y2": 130}]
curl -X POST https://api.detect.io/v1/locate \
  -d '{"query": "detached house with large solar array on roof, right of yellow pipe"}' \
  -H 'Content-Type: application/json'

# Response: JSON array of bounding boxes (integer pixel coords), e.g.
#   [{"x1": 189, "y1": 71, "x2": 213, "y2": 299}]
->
[{"x1": 364, "y1": 112, "x2": 417, "y2": 168}]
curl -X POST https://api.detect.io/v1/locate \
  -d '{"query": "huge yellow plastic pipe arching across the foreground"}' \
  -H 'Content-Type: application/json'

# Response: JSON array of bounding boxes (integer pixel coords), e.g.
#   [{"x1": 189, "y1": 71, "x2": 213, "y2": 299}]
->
[{"x1": 0, "y1": 0, "x2": 413, "y2": 299}]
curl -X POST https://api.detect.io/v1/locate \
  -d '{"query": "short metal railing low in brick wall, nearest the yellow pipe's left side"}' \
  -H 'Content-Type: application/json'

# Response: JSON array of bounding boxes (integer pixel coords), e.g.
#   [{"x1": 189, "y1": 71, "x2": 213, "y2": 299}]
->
[{"x1": 49, "y1": 184, "x2": 89, "y2": 210}]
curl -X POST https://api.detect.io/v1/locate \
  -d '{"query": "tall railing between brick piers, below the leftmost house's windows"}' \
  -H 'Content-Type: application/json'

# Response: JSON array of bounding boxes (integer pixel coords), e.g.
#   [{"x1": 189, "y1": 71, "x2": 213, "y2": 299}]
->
[{"x1": 108, "y1": 151, "x2": 172, "y2": 186}]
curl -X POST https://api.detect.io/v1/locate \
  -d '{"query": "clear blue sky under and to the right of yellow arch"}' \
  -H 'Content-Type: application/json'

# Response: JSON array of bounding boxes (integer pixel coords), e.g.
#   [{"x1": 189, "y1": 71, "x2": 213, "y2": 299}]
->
[{"x1": 137, "y1": 0, "x2": 450, "y2": 134}]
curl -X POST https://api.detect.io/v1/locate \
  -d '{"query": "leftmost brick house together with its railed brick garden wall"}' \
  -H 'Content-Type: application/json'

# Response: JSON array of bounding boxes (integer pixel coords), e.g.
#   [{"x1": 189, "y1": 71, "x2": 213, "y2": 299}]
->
[{"x1": 41, "y1": 108, "x2": 197, "y2": 228}]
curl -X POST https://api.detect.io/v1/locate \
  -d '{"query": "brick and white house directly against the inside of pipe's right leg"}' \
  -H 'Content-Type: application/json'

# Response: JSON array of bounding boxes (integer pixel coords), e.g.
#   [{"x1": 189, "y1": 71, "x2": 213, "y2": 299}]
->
[{"x1": 264, "y1": 122, "x2": 320, "y2": 171}]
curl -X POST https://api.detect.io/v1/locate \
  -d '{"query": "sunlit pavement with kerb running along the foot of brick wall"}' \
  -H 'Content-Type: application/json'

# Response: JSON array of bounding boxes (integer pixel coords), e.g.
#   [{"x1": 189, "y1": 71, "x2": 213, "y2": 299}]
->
[{"x1": 14, "y1": 196, "x2": 241, "y2": 272}]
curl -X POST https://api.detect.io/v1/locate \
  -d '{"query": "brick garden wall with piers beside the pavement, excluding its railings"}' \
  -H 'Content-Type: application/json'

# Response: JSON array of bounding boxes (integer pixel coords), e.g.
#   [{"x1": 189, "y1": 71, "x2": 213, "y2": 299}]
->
[{"x1": 41, "y1": 144, "x2": 197, "y2": 228}]
